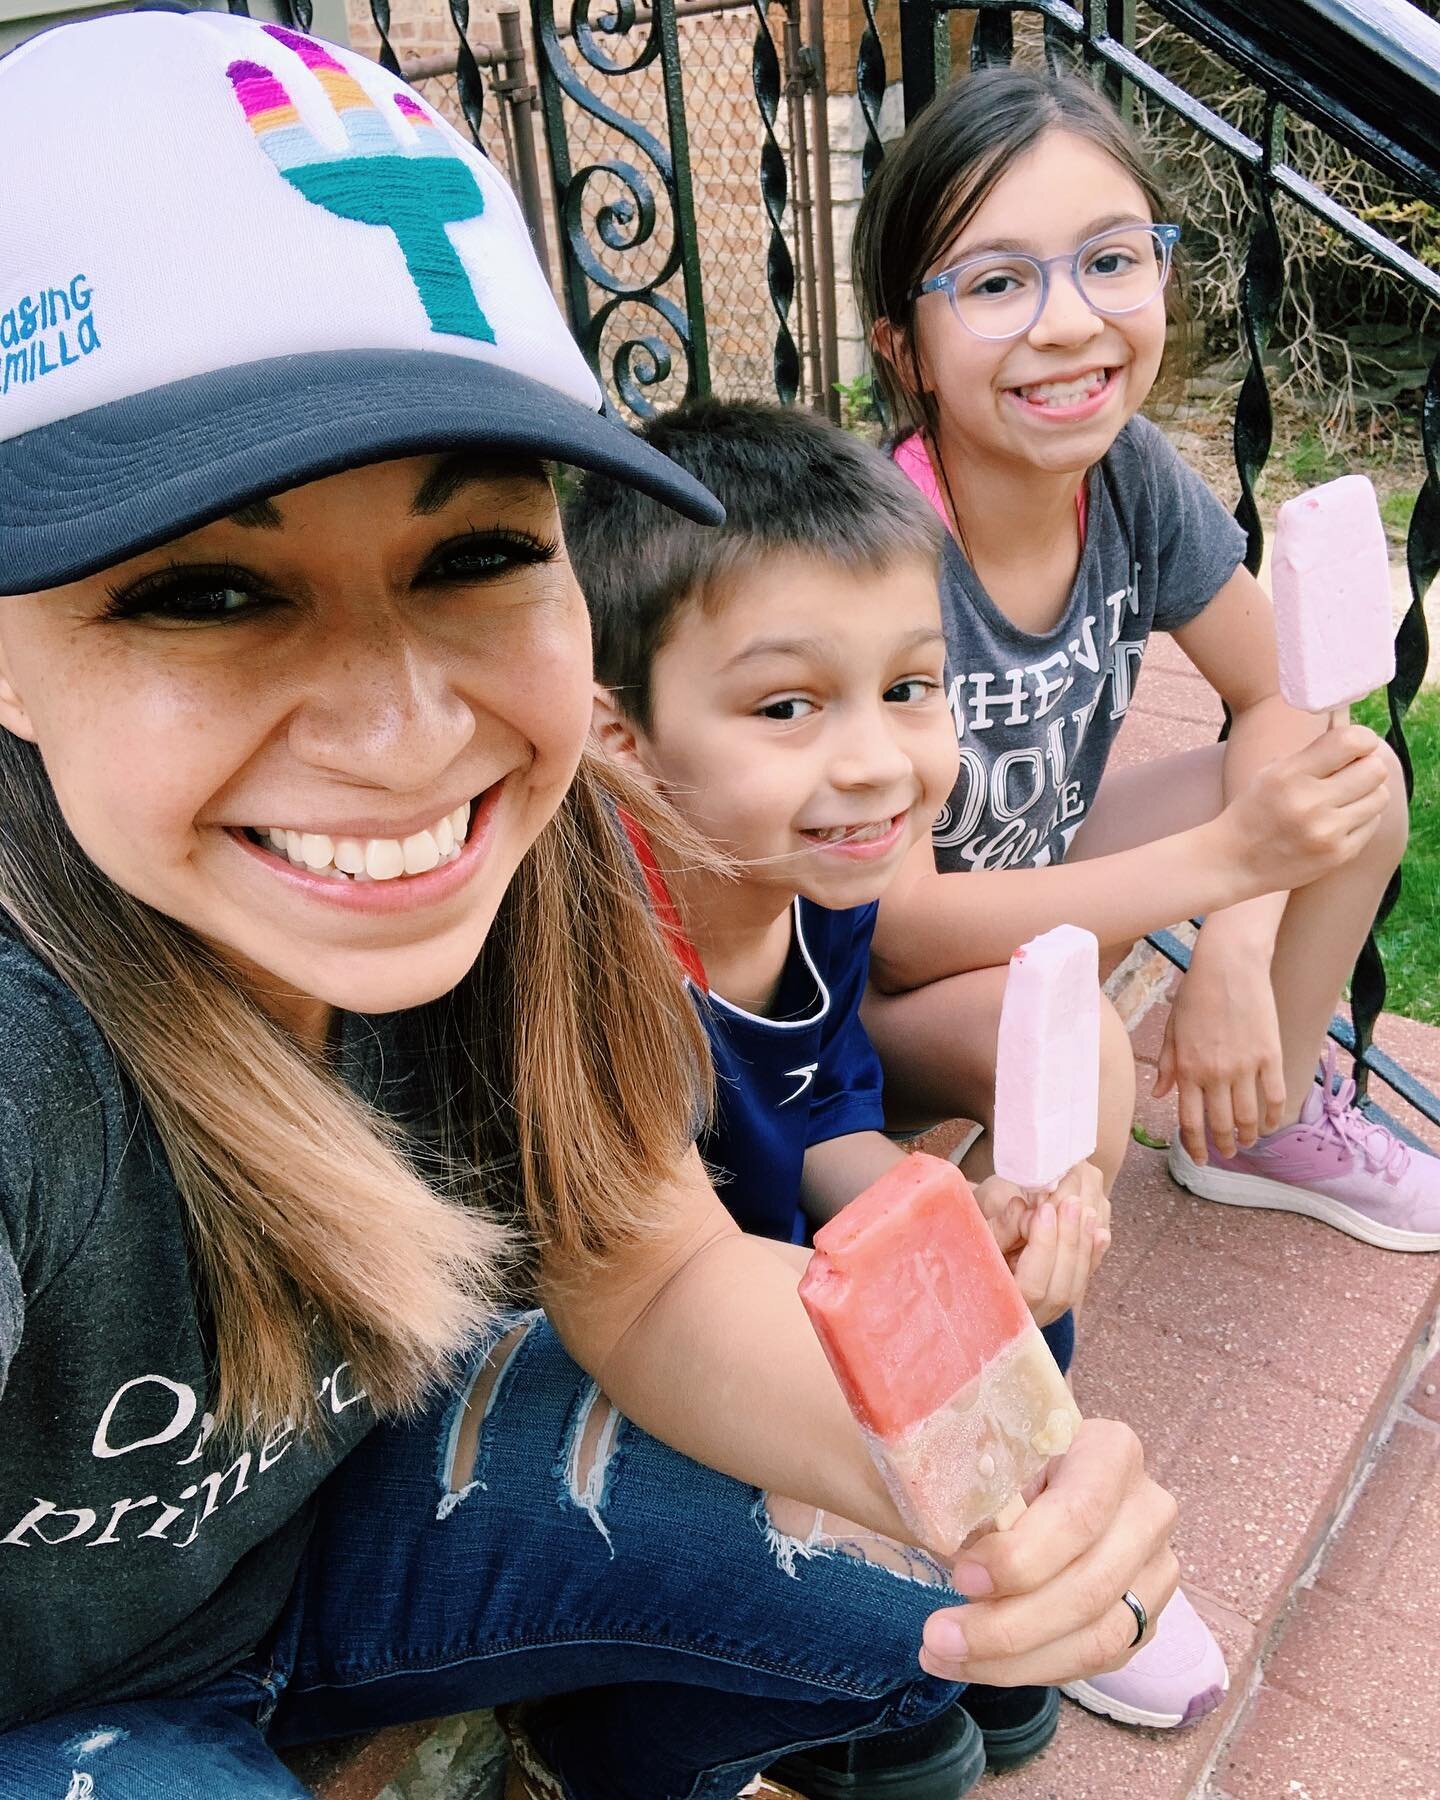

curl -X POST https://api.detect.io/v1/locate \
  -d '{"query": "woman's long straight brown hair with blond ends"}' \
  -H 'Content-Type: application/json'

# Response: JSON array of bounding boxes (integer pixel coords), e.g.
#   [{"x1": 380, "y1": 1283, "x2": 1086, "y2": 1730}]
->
[{"x1": 0, "y1": 731, "x2": 709, "y2": 1431}]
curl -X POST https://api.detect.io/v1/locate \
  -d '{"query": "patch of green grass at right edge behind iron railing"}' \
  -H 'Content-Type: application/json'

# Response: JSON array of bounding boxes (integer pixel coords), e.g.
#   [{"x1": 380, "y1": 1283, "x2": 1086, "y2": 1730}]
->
[{"x1": 1355, "y1": 688, "x2": 1440, "y2": 1024}]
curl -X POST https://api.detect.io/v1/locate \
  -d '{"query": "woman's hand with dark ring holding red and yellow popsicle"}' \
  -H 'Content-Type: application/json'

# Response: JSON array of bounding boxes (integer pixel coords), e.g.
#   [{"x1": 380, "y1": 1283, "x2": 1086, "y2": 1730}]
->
[{"x1": 920, "y1": 1418, "x2": 1179, "y2": 1687}]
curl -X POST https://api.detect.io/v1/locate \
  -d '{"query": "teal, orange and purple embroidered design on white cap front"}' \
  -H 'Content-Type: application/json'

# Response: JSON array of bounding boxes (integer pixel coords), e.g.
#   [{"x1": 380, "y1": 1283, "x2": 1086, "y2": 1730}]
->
[{"x1": 225, "y1": 25, "x2": 495, "y2": 344}]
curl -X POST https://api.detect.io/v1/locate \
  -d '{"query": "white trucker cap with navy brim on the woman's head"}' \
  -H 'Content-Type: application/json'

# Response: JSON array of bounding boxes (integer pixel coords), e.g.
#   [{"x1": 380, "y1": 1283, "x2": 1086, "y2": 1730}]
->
[{"x1": 0, "y1": 9, "x2": 724, "y2": 594}]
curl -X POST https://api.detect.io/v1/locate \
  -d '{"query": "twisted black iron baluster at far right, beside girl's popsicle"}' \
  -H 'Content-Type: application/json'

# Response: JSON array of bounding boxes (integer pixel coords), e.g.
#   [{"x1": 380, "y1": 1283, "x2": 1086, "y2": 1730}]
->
[{"x1": 1350, "y1": 347, "x2": 1440, "y2": 1093}]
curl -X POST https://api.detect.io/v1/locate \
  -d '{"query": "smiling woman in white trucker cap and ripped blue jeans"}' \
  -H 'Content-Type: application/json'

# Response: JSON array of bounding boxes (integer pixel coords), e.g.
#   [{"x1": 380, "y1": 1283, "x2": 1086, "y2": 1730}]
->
[{"x1": 0, "y1": 11, "x2": 1175, "y2": 1800}]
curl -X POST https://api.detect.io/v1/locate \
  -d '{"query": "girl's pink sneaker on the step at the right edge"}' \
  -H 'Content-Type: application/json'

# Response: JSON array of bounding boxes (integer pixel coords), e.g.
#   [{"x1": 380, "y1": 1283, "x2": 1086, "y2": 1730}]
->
[{"x1": 1170, "y1": 1049, "x2": 1440, "y2": 1249}]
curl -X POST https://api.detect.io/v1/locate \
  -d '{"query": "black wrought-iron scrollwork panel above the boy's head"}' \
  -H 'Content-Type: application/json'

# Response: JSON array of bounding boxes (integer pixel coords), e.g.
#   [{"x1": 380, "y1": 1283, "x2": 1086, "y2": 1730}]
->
[{"x1": 531, "y1": 0, "x2": 709, "y2": 414}]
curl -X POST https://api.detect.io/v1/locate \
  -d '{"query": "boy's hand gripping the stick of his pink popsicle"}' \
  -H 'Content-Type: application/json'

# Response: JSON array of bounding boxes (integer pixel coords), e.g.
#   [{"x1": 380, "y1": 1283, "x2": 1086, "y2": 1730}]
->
[{"x1": 976, "y1": 1163, "x2": 1111, "y2": 1325}]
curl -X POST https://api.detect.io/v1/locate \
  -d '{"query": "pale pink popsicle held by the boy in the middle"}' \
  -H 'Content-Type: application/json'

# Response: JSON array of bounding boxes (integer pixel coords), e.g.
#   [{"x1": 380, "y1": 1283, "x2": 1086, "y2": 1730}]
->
[{"x1": 994, "y1": 925, "x2": 1100, "y2": 1193}]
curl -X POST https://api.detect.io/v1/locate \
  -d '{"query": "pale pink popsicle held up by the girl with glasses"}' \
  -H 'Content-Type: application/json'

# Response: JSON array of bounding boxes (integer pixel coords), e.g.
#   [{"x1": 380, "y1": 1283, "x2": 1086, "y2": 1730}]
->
[{"x1": 1271, "y1": 475, "x2": 1395, "y2": 713}]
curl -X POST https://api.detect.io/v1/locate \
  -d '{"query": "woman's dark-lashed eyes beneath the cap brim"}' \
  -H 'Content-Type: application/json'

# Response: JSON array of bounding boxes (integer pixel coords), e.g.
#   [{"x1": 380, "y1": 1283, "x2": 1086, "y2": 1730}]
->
[{"x1": 103, "y1": 529, "x2": 560, "y2": 625}]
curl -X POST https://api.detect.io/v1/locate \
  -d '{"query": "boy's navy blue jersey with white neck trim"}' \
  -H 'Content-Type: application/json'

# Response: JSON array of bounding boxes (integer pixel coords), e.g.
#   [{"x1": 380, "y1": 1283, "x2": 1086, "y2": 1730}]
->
[{"x1": 697, "y1": 898, "x2": 886, "y2": 1244}]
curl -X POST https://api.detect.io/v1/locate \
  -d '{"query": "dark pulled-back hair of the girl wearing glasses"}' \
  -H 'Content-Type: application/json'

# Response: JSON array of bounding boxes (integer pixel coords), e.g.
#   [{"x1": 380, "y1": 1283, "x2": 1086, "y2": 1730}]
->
[{"x1": 851, "y1": 68, "x2": 1184, "y2": 436}]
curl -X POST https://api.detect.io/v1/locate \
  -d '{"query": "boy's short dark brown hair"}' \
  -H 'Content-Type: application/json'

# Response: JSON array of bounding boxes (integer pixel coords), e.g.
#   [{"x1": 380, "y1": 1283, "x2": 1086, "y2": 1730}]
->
[{"x1": 565, "y1": 400, "x2": 943, "y2": 729}]
